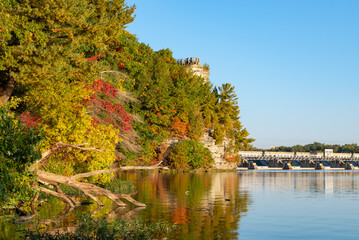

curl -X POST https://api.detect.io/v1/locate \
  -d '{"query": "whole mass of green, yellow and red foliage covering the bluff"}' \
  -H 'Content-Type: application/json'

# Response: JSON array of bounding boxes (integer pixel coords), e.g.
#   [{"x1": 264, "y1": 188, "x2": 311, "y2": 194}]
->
[{"x1": 0, "y1": 0, "x2": 253, "y2": 175}]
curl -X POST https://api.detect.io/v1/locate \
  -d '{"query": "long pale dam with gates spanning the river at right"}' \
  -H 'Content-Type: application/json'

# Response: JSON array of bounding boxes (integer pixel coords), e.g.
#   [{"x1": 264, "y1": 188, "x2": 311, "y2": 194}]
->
[{"x1": 238, "y1": 149, "x2": 359, "y2": 170}]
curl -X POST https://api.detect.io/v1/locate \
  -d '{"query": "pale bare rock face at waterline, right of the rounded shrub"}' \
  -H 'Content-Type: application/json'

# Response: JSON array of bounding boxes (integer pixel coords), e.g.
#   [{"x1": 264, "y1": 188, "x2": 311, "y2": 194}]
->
[{"x1": 201, "y1": 133, "x2": 237, "y2": 169}]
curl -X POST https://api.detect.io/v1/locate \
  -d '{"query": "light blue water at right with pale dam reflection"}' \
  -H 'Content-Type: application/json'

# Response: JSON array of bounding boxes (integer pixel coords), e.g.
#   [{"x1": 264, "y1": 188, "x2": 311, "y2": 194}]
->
[{"x1": 238, "y1": 171, "x2": 359, "y2": 240}]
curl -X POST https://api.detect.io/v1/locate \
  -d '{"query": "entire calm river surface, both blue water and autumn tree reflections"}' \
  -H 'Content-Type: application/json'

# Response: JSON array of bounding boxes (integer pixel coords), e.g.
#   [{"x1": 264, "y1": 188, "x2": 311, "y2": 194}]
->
[{"x1": 0, "y1": 171, "x2": 359, "y2": 239}]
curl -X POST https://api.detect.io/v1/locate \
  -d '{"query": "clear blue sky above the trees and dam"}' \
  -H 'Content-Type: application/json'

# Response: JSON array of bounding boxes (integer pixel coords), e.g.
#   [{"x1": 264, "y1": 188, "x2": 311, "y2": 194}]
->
[{"x1": 127, "y1": 0, "x2": 359, "y2": 148}]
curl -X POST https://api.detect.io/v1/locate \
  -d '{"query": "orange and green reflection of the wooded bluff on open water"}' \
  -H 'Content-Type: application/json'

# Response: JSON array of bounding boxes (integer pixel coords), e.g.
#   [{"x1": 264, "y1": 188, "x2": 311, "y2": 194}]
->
[{"x1": 116, "y1": 172, "x2": 250, "y2": 239}]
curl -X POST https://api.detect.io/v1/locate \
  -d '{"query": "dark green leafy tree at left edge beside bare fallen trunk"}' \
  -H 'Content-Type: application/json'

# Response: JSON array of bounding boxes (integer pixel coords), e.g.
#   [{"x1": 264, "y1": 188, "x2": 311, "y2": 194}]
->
[{"x1": 0, "y1": 107, "x2": 42, "y2": 208}]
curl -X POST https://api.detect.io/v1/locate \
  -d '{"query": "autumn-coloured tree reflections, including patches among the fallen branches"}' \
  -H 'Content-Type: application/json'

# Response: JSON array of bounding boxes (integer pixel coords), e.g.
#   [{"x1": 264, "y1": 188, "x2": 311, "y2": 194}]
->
[{"x1": 0, "y1": 171, "x2": 250, "y2": 239}]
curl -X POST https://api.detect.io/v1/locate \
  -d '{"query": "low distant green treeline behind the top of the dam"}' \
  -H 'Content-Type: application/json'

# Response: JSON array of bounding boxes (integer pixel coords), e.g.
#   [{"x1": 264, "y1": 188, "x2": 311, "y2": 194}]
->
[{"x1": 270, "y1": 142, "x2": 359, "y2": 153}]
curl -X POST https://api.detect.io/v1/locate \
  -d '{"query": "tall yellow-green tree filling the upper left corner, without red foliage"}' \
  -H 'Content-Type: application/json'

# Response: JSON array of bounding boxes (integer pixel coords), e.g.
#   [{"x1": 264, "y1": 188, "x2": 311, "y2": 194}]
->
[{"x1": 0, "y1": 0, "x2": 134, "y2": 172}]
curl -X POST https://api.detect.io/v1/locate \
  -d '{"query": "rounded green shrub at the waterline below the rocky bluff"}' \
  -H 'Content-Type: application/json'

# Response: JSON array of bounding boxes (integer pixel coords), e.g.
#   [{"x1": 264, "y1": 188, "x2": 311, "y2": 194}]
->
[{"x1": 168, "y1": 140, "x2": 214, "y2": 169}]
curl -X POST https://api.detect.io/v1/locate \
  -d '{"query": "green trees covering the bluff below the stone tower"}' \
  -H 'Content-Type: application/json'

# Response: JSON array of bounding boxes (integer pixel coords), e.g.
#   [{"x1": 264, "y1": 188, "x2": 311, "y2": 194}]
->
[{"x1": 99, "y1": 34, "x2": 253, "y2": 158}]
